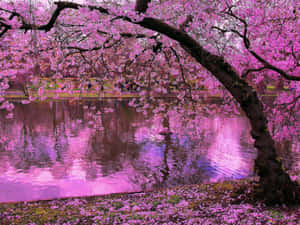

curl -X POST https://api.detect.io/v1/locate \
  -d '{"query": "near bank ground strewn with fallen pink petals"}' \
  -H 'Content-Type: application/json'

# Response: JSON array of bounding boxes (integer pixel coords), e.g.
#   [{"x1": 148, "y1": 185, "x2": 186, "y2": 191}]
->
[{"x1": 0, "y1": 180, "x2": 300, "y2": 225}]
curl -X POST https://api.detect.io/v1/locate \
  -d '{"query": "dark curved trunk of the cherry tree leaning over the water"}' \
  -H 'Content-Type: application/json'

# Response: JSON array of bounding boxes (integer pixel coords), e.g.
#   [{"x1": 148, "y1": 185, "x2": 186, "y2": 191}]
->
[{"x1": 139, "y1": 18, "x2": 300, "y2": 204}]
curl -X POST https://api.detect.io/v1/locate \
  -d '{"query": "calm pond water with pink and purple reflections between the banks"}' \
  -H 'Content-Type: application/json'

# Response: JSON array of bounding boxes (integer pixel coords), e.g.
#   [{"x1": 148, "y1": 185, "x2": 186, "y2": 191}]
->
[{"x1": 0, "y1": 101, "x2": 299, "y2": 202}]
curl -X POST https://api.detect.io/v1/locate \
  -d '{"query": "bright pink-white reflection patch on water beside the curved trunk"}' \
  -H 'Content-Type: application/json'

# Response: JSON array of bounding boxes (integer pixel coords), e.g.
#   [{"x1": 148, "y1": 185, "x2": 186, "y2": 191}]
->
[{"x1": 207, "y1": 117, "x2": 254, "y2": 182}]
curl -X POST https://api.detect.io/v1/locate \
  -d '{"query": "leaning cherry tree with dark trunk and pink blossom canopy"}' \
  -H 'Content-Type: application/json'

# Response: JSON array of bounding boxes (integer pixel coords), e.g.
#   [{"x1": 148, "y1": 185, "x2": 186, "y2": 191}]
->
[{"x1": 0, "y1": 0, "x2": 300, "y2": 203}]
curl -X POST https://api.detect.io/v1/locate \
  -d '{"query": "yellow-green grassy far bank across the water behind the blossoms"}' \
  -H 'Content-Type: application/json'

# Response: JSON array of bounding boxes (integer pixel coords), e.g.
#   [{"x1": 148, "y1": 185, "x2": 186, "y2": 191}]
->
[{"x1": 0, "y1": 78, "x2": 289, "y2": 100}]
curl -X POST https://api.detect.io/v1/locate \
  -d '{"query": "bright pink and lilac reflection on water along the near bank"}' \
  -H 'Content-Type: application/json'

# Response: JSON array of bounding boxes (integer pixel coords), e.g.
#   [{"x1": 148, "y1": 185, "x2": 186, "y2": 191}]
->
[{"x1": 0, "y1": 160, "x2": 140, "y2": 202}]
